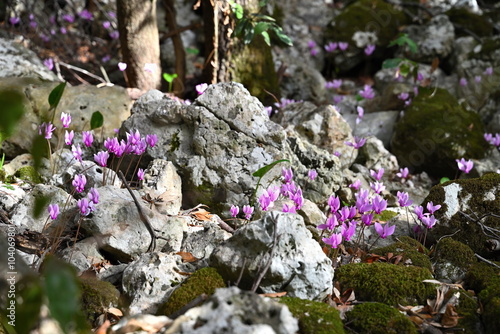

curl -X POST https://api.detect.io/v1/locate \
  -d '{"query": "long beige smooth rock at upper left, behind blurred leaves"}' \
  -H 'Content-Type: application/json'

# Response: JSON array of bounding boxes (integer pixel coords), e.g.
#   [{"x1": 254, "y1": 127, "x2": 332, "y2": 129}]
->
[{"x1": 0, "y1": 78, "x2": 132, "y2": 157}]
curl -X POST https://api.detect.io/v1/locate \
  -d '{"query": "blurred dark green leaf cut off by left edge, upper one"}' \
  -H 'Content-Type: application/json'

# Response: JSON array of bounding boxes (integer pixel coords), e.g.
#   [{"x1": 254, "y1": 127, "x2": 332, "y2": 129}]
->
[{"x1": 0, "y1": 90, "x2": 25, "y2": 140}]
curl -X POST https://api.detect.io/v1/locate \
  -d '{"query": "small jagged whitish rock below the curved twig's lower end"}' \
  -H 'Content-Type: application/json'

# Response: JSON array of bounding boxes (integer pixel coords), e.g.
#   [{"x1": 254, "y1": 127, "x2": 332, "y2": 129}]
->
[{"x1": 122, "y1": 253, "x2": 191, "y2": 315}]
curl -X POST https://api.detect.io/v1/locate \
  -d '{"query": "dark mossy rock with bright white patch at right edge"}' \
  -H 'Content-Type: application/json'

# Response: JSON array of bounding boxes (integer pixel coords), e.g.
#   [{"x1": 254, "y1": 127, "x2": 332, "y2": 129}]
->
[{"x1": 424, "y1": 173, "x2": 500, "y2": 257}]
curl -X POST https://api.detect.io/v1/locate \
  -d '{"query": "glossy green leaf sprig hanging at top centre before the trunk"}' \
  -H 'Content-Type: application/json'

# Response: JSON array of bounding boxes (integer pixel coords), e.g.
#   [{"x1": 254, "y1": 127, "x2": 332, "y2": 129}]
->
[{"x1": 229, "y1": 1, "x2": 293, "y2": 46}]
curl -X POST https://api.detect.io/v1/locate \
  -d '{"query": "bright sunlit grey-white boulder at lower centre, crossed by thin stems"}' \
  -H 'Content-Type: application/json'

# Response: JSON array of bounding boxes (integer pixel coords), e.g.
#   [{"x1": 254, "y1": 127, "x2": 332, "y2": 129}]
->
[{"x1": 210, "y1": 212, "x2": 333, "y2": 300}]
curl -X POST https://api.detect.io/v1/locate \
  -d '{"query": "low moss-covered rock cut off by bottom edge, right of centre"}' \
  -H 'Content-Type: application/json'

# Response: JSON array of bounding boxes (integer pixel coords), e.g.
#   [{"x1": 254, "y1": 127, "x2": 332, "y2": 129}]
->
[{"x1": 346, "y1": 303, "x2": 417, "y2": 334}]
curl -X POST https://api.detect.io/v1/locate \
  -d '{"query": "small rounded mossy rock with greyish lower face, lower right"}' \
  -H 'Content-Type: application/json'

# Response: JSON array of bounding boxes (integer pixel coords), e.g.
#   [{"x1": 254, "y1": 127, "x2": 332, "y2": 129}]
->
[{"x1": 433, "y1": 237, "x2": 477, "y2": 283}]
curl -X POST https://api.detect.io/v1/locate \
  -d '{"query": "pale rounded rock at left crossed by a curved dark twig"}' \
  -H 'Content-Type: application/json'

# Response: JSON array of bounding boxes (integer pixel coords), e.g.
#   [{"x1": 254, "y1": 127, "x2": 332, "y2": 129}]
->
[{"x1": 81, "y1": 186, "x2": 185, "y2": 262}]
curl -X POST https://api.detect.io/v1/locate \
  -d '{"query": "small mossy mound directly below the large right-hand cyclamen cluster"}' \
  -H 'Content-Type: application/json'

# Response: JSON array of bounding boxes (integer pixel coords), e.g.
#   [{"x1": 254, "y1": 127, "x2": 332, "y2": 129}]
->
[{"x1": 372, "y1": 236, "x2": 432, "y2": 271}]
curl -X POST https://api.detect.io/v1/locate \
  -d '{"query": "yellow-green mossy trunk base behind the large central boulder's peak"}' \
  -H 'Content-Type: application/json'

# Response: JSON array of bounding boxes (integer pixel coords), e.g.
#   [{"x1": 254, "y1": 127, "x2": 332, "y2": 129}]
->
[{"x1": 230, "y1": 36, "x2": 280, "y2": 105}]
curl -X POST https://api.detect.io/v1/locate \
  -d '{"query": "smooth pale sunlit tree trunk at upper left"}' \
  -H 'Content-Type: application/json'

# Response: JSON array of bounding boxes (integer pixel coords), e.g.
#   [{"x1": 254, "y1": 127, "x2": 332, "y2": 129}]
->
[{"x1": 116, "y1": 0, "x2": 161, "y2": 90}]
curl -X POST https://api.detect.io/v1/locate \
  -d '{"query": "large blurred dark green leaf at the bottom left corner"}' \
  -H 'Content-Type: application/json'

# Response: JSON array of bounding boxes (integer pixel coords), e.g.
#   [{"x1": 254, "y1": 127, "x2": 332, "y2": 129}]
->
[{"x1": 43, "y1": 256, "x2": 86, "y2": 333}]
